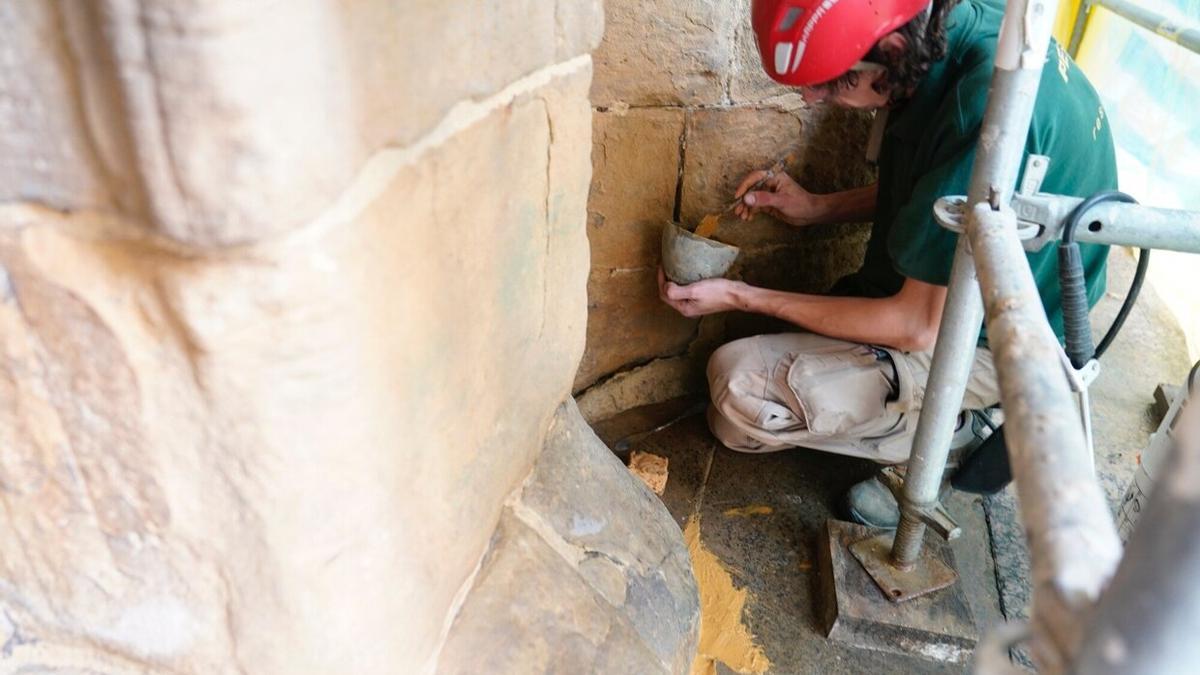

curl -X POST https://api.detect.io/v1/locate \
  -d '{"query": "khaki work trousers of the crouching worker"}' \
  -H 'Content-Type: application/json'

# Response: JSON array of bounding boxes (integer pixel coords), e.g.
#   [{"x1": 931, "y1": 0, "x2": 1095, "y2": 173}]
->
[{"x1": 708, "y1": 333, "x2": 1000, "y2": 464}]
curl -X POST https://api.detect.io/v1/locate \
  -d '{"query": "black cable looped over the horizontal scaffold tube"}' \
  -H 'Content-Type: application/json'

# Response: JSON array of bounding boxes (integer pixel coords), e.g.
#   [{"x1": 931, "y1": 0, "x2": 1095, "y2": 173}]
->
[{"x1": 1058, "y1": 190, "x2": 1150, "y2": 369}]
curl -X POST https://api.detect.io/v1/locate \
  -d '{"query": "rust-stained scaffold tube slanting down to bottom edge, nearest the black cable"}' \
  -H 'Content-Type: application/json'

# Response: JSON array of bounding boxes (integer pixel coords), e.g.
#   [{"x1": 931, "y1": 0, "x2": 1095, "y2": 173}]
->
[{"x1": 968, "y1": 204, "x2": 1121, "y2": 673}]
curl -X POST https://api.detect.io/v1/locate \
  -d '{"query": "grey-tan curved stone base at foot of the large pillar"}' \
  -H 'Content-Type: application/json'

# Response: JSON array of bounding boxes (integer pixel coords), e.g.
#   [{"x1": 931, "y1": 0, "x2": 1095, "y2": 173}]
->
[{"x1": 440, "y1": 400, "x2": 700, "y2": 673}]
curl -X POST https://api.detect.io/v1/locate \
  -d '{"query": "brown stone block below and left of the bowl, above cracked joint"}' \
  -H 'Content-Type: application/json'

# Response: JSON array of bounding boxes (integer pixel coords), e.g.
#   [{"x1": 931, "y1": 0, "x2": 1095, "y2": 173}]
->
[{"x1": 575, "y1": 267, "x2": 696, "y2": 392}]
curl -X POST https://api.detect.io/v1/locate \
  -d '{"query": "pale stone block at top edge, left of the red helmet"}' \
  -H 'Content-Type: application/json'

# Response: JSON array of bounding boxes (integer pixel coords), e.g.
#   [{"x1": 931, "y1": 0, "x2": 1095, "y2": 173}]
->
[{"x1": 592, "y1": 0, "x2": 737, "y2": 107}]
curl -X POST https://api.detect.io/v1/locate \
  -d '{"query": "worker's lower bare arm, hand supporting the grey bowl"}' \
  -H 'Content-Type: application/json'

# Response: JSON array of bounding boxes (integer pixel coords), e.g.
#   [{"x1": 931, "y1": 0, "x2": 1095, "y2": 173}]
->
[{"x1": 659, "y1": 270, "x2": 946, "y2": 352}]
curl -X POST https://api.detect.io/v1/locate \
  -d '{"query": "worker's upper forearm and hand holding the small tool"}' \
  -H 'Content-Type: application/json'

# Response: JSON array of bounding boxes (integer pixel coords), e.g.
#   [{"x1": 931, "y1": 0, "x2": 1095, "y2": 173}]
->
[{"x1": 733, "y1": 171, "x2": 878, "y2": 227}]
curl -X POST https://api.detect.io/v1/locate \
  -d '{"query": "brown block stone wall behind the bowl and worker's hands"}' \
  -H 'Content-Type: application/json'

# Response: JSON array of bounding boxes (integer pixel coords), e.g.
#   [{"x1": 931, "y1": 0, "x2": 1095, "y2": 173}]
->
[{"x1": 575, "y1": 0, "x2": 871, "y2": 420}]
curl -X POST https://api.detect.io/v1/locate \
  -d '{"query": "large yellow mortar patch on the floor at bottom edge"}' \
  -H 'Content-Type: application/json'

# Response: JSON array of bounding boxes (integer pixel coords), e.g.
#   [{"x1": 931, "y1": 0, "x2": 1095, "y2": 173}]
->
[{"x1": 683, "y1": 515, "x2": 770, "y2": 675}]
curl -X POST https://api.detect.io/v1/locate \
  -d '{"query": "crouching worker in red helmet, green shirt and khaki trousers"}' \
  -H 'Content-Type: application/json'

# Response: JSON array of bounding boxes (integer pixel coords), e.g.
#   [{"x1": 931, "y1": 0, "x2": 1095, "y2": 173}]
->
[{"x1": 659, "y1": 0, "x2": 1116, "y2": 527}]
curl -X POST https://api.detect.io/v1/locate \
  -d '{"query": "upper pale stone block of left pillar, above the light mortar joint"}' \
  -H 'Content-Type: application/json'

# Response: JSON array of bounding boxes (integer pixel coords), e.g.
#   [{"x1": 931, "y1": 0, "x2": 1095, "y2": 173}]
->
[{"x1": 0, "y1": 0, "x2": 602, "y2": 247}]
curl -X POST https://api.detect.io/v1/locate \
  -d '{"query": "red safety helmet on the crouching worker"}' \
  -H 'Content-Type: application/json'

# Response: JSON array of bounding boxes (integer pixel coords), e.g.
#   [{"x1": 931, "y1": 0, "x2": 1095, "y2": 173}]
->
[{"x1": 750, "y1": 0, "x2": 930, "y2": 86}]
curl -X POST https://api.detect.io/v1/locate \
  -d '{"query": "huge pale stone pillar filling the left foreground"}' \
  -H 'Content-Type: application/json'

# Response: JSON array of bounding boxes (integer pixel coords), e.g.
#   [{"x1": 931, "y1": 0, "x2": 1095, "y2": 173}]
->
[{"x1": 0, "y1": 0, "x2": 695, "y2": 675}]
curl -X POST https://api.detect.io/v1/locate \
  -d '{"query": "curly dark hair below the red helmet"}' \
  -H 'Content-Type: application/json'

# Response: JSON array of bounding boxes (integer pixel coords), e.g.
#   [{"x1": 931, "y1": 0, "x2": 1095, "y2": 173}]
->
[{"x1": 824, "y1": 0, "x2": 959, "y2": 106}]
